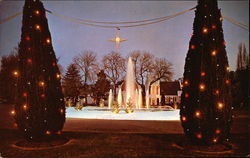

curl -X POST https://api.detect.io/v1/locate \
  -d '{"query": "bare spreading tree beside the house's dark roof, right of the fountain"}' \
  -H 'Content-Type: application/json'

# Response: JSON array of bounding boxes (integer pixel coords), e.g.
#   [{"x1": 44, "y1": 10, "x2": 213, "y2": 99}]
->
[{"x1": 150, "y1": 58, "x2": 173, "y2": 86}]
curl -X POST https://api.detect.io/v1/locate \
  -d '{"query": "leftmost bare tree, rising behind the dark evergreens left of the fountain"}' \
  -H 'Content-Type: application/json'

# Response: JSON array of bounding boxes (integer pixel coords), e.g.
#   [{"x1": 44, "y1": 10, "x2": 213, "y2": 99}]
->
[{"x1": 73, "y1": 51, "x2": 99, "y2": 85}]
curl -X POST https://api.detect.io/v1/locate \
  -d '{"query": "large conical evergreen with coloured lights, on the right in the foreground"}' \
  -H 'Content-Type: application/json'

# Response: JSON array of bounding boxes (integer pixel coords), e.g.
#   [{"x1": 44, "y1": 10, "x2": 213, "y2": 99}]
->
[{"x1": 180, "y1": 0, "x2": 232, "y2": 144}]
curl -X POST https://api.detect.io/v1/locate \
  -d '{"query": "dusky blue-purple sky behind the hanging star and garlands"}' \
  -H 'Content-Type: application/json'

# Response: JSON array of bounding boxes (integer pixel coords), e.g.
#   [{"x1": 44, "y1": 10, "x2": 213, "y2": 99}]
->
[{"x1": 0, "y1": 0, "x2": 249, "y2": 78}]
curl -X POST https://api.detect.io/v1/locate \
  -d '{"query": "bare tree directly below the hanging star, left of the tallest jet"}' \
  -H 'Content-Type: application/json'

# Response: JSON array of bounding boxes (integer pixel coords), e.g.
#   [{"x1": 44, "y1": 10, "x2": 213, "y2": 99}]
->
[{"x1": 102, "y1": 51, "x2": 126, "y2": 96}]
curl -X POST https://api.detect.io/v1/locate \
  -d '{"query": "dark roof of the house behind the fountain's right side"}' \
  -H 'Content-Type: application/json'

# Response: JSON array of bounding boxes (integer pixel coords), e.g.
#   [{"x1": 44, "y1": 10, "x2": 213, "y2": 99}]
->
[{"x1": 160, "y1": 81, "x2": 181, "y2": 95}]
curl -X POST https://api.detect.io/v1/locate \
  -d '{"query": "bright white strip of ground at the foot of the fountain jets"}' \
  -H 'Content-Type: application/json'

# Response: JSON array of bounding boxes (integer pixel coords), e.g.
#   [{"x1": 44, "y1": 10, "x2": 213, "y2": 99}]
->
[{"x1": 66, "y1": 107, "x2": 180, "y2": 120}]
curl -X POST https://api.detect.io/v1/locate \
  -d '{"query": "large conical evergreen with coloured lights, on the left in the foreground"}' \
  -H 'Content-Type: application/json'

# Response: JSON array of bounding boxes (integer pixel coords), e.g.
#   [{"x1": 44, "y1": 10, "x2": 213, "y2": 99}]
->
[{"x1": 15, "y1": 0, "x2": 65, "y2": 141}]
